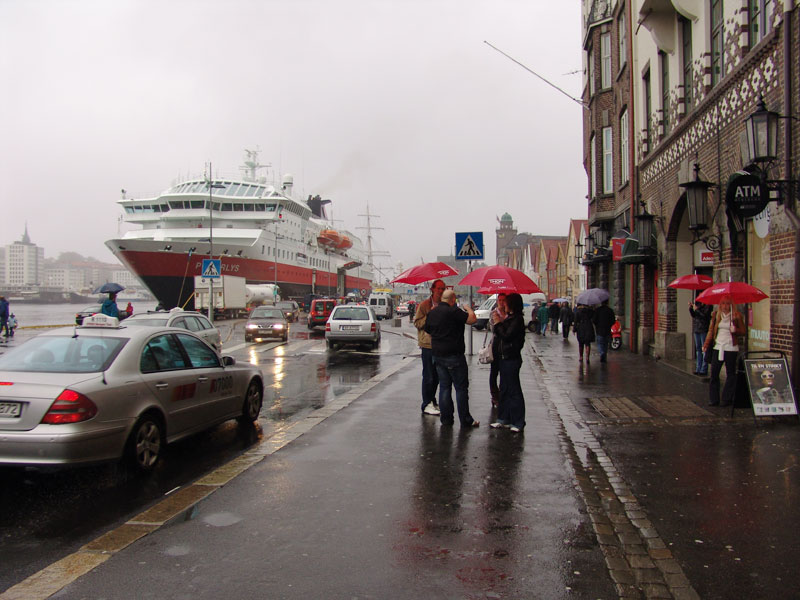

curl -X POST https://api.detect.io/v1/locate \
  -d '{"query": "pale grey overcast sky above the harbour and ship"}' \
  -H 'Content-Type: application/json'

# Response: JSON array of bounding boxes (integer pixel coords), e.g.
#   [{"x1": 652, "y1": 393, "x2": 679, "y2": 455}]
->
[{"x1": 0, "y1": 0, "x2": 587, "y2": 282}]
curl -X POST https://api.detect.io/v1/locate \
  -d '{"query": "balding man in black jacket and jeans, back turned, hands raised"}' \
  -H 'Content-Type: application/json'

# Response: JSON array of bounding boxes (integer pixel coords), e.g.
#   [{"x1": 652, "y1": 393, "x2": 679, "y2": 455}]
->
[{"x1": 425, "y1": 290, "x2": 480, "y2": 427}]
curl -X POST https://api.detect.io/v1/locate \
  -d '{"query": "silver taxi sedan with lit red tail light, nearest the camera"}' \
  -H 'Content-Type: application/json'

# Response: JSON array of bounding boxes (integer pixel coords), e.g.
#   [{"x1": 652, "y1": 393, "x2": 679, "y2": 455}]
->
[{"x1": 0, "y1": 315, "x2": 264, "y2": 472}]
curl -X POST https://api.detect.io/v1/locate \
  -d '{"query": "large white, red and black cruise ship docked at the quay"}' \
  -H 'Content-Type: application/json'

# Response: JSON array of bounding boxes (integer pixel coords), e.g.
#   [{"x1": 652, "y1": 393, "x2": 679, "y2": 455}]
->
[{"x1": 106, "y1": 150, "x2": 373, "y2": 309}]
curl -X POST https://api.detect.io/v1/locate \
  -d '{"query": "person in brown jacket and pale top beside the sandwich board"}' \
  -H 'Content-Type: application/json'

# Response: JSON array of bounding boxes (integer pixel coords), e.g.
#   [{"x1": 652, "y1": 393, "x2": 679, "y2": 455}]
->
[{"x1": 703, "y1": 298, "x2": 745, "y2": 406}]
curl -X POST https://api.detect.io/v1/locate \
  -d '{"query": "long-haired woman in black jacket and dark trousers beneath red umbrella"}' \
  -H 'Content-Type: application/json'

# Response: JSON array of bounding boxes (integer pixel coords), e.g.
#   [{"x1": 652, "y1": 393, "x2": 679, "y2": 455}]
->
[{"x1": 490, "y1": 294, "x2": 525, "y2": 433}]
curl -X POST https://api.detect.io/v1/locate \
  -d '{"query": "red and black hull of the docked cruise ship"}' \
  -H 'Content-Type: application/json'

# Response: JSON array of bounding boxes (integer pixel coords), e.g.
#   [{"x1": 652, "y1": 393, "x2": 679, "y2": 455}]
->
[{"x1": 106, "y1": 239, "x2": 372, "y2": 309}]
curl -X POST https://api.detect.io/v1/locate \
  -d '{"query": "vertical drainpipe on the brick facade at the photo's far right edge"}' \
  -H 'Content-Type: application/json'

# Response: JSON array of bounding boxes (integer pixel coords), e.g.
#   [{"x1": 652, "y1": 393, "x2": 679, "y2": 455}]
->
[{"x1": 783, "y1": 3, "x2": 800, "y2": 397}]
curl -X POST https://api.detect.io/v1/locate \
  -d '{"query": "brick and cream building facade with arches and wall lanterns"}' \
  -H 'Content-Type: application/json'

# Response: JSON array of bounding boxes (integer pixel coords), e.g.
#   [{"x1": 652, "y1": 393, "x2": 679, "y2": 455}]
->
[{"x1": 583, "y1": 0, "x2": 800, "y2": 384}]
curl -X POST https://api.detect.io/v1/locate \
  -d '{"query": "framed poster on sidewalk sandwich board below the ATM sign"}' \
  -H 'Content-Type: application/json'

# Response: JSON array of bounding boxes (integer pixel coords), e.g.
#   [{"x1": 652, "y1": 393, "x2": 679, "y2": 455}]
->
[{"x1": 744, "y1": 358, "x2": 797, "y2": 417}]
